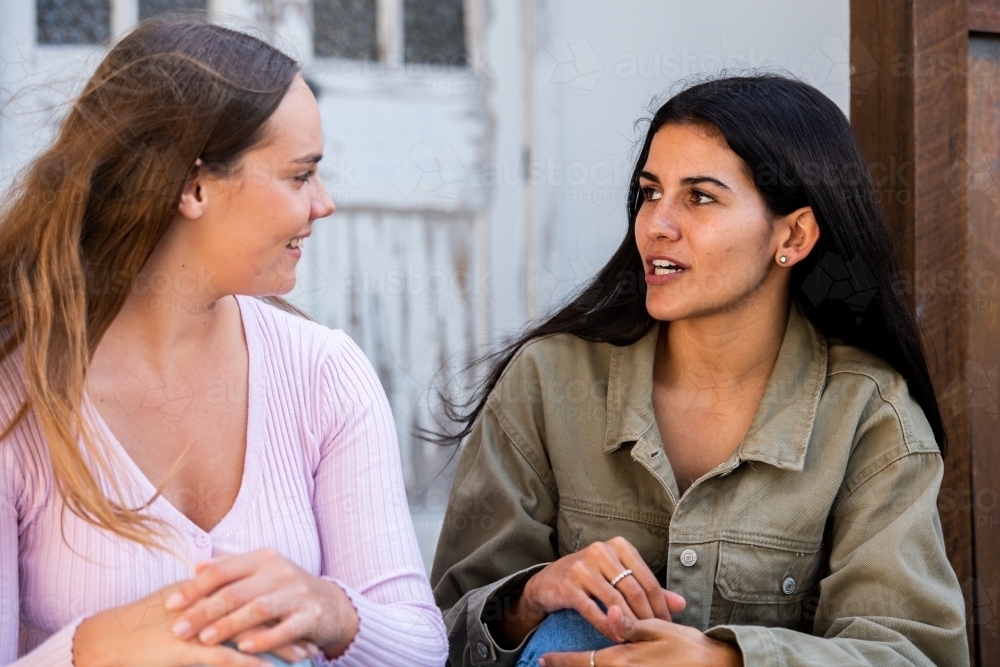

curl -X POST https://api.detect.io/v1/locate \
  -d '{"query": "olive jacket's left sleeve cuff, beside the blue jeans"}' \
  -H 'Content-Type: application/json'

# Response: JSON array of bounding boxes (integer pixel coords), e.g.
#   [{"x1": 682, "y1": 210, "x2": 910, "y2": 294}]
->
[{"x1": 466, "y1": 563, "x2": 549, "y2": 667}]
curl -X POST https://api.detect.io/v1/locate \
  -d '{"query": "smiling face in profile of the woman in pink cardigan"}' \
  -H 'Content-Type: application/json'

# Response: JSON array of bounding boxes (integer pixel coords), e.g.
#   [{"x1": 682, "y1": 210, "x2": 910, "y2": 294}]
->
[{"x1": 191, "y1": 77, "x2": 335, "y2": 296}]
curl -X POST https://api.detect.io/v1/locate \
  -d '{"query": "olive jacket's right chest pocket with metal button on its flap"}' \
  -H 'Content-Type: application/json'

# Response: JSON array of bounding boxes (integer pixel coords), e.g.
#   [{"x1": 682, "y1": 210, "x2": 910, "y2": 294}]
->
[{"x1": 713, "y1": 542, "x2": 822, "y2": 629}]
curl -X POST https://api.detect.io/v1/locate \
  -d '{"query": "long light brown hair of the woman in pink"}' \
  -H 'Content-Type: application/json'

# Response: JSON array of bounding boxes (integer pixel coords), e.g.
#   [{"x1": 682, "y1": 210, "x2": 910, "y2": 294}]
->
[{"x1": 0, "y1": 18, "x2": 299, "y2": 546}]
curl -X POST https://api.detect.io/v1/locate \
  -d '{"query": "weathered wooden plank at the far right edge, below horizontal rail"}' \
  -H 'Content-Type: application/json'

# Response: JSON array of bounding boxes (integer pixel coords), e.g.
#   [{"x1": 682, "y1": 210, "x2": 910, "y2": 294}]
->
[{"x1": 956, "y1": 34, "x2": 1000, "y2": 665}]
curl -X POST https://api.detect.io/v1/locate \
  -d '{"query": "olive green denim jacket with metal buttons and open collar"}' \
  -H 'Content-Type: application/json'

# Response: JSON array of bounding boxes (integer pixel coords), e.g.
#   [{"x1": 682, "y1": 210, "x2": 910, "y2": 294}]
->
[{"x1": 431, "y1": 305, "x2": 969, "y2": 667}]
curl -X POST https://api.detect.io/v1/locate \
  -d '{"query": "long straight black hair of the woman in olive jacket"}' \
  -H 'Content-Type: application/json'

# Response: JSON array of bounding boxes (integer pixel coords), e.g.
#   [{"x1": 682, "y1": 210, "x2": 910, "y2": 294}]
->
[{"x1": 432, "y1": 75, "x2": 947, "y2": 453}]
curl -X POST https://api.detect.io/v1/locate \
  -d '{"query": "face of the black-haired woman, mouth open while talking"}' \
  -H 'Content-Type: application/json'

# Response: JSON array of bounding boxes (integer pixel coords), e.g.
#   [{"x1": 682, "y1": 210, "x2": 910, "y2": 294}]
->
[{"x1": 635, "y1": 124, "x2": 781, "y2": 321}]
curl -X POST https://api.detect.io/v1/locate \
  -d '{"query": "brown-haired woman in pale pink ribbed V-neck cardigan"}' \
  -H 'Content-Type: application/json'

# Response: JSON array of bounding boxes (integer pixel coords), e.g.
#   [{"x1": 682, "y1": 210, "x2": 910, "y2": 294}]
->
[{"x1": 0, "y1": 21, "x2": 446, "y2": 667}]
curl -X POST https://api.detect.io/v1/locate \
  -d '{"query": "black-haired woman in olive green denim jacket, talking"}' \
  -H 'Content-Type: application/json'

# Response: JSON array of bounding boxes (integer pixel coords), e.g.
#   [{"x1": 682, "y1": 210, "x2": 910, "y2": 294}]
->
[{"x1": 431, "y1": 76, "x2": 968, "y2": 667}]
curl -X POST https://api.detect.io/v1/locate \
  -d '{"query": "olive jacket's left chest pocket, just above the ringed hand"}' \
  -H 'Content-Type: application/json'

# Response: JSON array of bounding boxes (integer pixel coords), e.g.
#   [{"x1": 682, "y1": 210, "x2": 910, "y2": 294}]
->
[{"x1": 556, "y1": 501, "x2": 669, "y2": 584}]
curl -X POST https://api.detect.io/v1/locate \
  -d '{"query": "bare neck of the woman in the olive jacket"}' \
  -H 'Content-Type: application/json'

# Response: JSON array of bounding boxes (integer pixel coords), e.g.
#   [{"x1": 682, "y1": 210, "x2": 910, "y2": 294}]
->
[{"x1": 654, "y1": 296, "x2": 789, "y2": 395}]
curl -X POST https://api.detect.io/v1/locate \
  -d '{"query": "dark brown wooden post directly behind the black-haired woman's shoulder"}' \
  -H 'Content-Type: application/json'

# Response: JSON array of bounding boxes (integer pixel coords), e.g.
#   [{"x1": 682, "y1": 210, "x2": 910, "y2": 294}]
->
[{"x1": 851, "y1": 0, "x2": 976, "y2": 664}]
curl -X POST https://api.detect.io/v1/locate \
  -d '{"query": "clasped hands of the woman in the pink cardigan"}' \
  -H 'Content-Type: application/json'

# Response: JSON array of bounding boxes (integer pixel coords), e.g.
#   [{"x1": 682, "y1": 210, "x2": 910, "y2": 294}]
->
[{"x1": 74, "y1": 549, "x2": 359, "y2": 667}]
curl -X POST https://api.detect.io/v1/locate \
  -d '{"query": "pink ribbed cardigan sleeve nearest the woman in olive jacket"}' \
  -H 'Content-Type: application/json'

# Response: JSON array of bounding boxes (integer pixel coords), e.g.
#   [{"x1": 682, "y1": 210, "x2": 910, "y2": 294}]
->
[{"x1": 313, "y1": 334, "x2": 447, "y2": 667}]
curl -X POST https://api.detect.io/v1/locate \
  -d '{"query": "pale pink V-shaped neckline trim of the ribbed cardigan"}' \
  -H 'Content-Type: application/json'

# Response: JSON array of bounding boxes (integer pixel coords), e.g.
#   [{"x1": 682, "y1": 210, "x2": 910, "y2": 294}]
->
[{"x1": 84, "y1": 296, "x2": 264, "y2": 538}]
